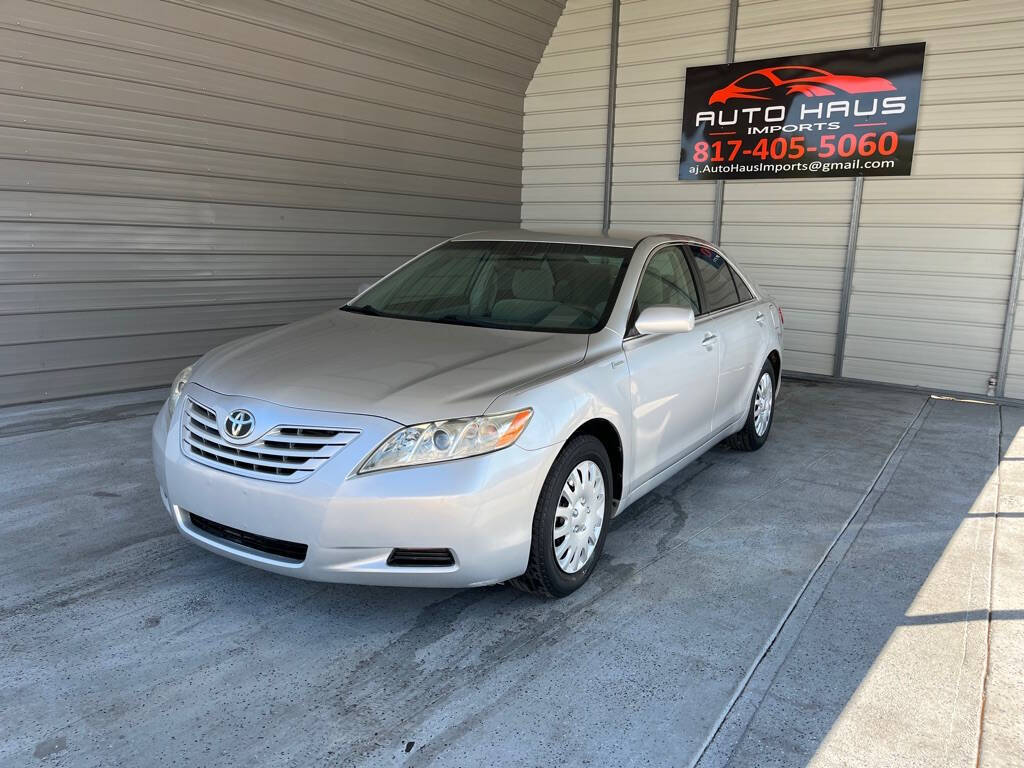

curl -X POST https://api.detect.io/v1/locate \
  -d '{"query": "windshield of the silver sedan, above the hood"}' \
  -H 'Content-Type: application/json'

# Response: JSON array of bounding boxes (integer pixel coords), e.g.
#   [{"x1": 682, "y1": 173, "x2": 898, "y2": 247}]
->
[{"x1": 342, "y1": 241, "x2": 633, "y2": 333}]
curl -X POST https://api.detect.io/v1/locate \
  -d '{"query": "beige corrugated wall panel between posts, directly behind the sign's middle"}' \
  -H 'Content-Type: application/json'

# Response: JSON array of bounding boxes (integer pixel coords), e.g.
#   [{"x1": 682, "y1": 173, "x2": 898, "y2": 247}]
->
[{"x1": 722, "y1": 0, "x2": 872, "y2": 375}]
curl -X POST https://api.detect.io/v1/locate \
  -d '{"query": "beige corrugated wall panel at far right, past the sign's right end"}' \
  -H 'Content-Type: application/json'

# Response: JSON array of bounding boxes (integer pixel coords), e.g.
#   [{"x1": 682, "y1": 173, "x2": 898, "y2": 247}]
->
[{"x1": 843, "y1": 0, "x2": 1024, "y2": 396}]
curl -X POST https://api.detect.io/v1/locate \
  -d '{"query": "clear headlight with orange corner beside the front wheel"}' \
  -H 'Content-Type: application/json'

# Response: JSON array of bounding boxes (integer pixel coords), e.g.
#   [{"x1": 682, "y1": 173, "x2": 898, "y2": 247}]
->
[{"x1": 359, "y1": 408, "x2": 534, "y2": 474}]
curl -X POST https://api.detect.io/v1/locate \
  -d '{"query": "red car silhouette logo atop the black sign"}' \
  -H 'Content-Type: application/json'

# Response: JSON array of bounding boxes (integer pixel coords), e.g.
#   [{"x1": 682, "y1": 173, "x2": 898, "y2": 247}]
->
[{"x1": 708, "y1": 67, "x2": 896, "y2": 104}]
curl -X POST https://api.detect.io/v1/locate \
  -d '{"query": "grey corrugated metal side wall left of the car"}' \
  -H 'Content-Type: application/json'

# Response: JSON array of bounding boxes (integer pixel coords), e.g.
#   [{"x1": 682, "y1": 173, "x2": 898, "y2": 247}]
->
[{"x1": 0, "y1": 0, "x2": 561, "y2": 403}]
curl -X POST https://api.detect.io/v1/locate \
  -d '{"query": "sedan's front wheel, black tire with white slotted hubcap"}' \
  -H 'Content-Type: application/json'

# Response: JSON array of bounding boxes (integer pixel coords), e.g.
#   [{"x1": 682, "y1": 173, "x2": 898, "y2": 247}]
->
[{"x1": 511, "y1": 435, "x2": 612, "y2": 597}]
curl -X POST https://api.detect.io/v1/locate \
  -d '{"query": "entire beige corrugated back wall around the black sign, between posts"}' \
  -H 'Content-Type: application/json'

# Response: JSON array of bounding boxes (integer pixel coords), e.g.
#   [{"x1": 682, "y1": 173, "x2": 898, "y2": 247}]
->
[{"x1": 523, "y1": 0, "x2": 1024, "y2": 396}]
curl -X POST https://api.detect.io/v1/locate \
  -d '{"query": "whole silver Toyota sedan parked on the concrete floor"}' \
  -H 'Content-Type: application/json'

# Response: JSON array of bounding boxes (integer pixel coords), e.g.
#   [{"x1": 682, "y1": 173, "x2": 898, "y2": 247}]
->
[{"x1": 153, "y1": 230, "x2": 782, "y2": 597}]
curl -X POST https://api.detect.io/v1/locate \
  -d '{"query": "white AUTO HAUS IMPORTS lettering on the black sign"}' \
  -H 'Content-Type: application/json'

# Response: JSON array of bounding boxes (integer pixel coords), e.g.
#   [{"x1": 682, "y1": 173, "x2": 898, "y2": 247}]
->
[{"x1": 694, "y1": 96, "x2": 906, "y2": 135}]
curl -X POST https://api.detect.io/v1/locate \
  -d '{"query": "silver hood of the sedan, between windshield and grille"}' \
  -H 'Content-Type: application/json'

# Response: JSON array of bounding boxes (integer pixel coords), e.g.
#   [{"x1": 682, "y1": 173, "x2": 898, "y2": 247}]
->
[{"x1": 193, "y1": 310, "x2": 588, "y2": 424}]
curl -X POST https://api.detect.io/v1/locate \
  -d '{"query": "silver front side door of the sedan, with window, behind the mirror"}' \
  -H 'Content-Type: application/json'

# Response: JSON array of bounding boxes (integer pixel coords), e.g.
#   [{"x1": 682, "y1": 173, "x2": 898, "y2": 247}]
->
[{"x1": 623, "y1": 246, "x2": 719, "y2": 482}]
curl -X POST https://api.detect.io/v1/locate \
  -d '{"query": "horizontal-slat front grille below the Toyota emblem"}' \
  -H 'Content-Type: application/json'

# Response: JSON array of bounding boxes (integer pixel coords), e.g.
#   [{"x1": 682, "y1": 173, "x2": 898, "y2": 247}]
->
[{"x1": 181, "y1": 398, "x2": 358, "y2": 482}]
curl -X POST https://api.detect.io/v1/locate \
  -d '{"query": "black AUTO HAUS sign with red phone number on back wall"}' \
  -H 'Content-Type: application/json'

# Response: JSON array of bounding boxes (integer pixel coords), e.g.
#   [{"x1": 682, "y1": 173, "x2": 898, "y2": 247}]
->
[{"x1": 679, "y1": 43, "x2": 925, "y2": 180}]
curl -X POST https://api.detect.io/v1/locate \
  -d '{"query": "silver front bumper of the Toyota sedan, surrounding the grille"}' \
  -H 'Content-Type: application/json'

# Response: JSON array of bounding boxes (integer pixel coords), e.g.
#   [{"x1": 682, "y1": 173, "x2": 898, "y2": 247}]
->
[{"x1": 153, "y1": 384, "x2": 558, "y2": 587}]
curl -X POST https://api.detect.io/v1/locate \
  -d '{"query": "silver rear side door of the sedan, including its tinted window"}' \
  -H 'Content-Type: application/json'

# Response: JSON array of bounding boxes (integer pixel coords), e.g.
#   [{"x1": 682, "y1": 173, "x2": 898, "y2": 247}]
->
[{"x1": 689, "y1": 245, "x2": 764, "y2": 433}]
